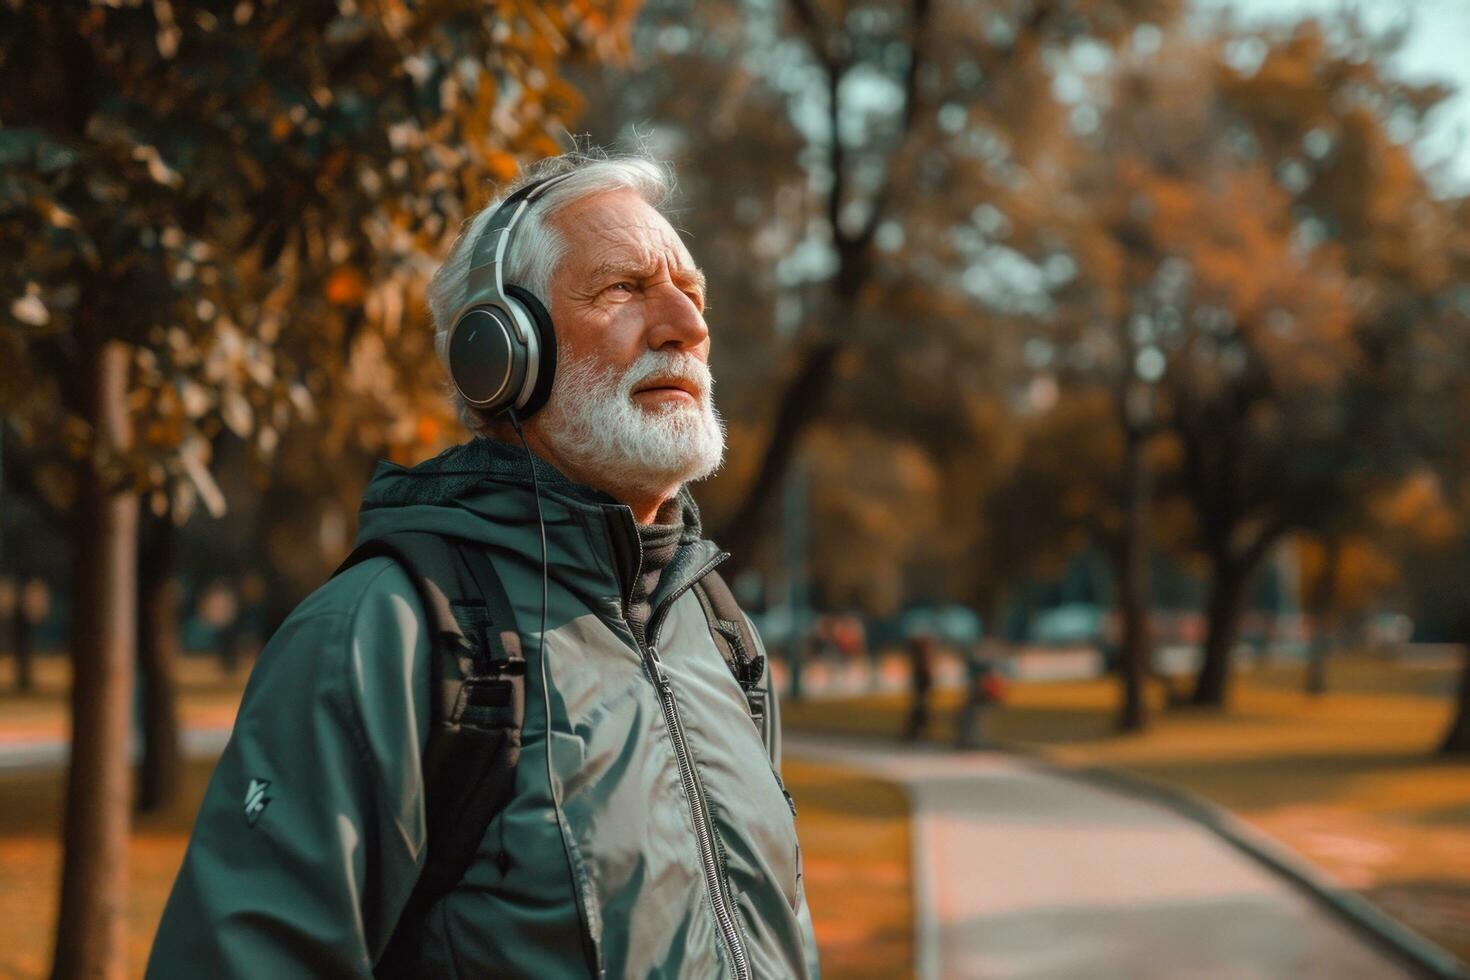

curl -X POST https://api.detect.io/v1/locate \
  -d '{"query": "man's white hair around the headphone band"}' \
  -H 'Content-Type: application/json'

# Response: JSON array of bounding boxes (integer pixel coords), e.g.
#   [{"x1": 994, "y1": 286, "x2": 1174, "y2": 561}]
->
[{"x1": 428, "y1": 147, "x2": 673, "y2": 435}]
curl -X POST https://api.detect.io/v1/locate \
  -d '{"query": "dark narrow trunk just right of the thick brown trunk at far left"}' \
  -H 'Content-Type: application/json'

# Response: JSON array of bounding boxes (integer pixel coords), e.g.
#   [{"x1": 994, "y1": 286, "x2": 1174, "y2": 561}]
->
[{"x1": 138, "y1": 514, "x2": 184, "y2": 813}]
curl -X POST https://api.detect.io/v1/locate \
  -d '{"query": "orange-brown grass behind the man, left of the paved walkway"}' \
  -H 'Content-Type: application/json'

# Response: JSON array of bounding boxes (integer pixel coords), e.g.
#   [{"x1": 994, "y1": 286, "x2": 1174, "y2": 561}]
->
[{"x1": 0, "y1": 664, "x2": 913, "y2": 977}]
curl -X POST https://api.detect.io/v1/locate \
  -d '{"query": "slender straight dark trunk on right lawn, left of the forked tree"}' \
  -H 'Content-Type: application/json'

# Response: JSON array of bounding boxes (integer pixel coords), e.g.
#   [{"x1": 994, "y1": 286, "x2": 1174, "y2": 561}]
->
[{"x1": 1117, "y1": 426, "x2": 1152, "y2": 732}]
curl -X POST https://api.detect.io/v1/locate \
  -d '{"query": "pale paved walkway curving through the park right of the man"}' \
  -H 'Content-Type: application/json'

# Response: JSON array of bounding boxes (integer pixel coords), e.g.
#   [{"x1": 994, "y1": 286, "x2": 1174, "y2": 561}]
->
[{"x1": 785, "y1": 733, "x2": 1416, "y2": 980}]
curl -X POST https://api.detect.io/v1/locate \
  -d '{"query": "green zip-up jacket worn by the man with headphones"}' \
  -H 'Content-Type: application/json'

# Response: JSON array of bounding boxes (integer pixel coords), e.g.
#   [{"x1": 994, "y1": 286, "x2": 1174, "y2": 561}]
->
[{"x1": 147, "y1": 439, "x2": 817, "y2": 980}]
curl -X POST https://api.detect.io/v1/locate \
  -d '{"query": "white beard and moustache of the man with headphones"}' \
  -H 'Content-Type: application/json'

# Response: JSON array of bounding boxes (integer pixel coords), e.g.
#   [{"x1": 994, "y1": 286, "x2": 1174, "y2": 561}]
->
[{"x1": 541, "y1": 351, "x2": 725, "y2": 494}]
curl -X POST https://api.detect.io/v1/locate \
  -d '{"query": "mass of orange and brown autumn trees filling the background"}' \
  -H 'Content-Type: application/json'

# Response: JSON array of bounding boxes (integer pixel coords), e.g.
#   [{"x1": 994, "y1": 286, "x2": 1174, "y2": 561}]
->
[{"x1": 0, "y1": 0, "x2": 1470, "y2": 976}]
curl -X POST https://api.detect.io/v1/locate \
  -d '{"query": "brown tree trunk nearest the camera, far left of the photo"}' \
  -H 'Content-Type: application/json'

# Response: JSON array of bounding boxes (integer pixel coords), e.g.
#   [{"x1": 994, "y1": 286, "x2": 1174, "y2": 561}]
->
[{"x1": 51, "y1": 335, "x2": 138, "y2": 980}]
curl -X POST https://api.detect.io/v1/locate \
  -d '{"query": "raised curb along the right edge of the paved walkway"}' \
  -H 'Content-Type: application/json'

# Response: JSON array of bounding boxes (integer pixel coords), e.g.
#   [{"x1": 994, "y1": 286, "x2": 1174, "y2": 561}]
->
[{"x1": 1011, "y1": 745, "x2": 1470, "y2": 980}]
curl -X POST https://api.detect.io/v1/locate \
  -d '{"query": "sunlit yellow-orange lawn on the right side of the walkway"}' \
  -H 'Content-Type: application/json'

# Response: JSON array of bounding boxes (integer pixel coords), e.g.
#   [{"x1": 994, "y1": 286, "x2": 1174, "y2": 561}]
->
[{"x1": 782, "y1": 657, "x2": 1470, "y2": 959}]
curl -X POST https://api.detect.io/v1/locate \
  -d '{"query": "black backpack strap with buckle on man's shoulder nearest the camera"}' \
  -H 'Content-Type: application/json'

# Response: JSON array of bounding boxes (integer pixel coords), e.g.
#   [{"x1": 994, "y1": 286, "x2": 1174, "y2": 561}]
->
[{"x1": 337, "y1": 532, "x2": 526, "y2": 977}]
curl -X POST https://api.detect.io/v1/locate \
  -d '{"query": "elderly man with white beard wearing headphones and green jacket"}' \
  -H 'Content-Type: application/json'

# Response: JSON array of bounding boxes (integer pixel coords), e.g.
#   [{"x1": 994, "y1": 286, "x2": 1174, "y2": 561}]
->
[{"x1": 148, "y1": 154, "x2": 817, "y2": 979}]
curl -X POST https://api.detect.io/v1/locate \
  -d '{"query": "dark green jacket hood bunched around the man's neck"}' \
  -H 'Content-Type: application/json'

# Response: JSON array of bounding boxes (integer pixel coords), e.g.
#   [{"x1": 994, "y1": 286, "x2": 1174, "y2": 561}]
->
[{"x1": 353, "y1": 436, "x2": 703, "y2": 547}]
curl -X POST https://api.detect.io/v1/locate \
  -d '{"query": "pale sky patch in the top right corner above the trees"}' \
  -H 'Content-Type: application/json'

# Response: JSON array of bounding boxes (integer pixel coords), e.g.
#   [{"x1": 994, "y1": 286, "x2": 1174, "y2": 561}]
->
[{"x1": 1194, "y1": 0, "x2": 1470, "y2": 194}]
